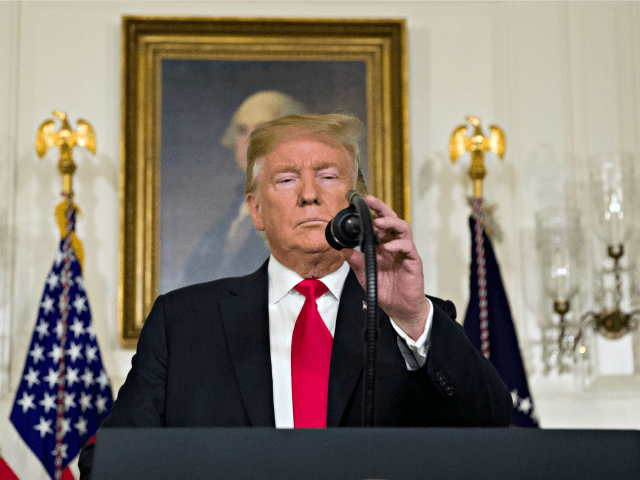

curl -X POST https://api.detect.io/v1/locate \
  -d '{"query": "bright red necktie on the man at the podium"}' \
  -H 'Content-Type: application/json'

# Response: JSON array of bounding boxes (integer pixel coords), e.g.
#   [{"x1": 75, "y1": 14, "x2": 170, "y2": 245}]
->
[{"x1": 291, "y1": 279, "x2": 333, "y2": 428}]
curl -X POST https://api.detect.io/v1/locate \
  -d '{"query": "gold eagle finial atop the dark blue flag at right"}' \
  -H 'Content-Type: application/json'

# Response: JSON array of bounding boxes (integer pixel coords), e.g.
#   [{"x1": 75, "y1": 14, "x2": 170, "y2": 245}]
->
[{"x1": 449, "y1": 116, "x2": 506, "y2": 197}]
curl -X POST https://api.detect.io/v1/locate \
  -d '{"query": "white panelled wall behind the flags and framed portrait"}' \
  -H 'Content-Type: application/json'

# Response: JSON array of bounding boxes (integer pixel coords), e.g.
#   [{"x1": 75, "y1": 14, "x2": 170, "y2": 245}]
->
[{"x1": 0, "y1": 0, "x2": 640, "y2": 468}]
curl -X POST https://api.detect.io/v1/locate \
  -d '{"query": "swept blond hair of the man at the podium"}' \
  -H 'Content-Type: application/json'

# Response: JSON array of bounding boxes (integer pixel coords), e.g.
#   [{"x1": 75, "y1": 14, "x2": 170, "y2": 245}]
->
[{"x1": 245, "y1": 113, "x2": 367, "y2": 195}]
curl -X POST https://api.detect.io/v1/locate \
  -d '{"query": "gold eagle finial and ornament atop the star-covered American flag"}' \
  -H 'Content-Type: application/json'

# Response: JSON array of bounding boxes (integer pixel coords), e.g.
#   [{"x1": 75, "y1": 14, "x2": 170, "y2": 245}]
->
[{"x1": 36, "y1": 110, "x2": 96, "y2": 265}]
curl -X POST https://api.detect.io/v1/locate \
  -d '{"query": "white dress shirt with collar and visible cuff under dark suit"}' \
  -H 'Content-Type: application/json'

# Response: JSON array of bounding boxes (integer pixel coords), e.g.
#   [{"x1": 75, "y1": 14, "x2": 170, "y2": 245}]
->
[{"x1": 268, "y1": 255, "x2": 433, "y2": 428}]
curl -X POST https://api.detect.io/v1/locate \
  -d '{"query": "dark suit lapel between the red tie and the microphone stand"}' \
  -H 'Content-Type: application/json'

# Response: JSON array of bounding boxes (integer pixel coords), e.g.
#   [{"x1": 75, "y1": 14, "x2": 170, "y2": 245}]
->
[{"x1": 327, "y1": 271, "x2": 365, "y2": 427}]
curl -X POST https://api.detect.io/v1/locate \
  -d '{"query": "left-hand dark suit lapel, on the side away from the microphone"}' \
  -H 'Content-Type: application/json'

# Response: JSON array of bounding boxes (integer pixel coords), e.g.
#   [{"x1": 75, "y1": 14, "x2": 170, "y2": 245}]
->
[{"x1": 220, "y1": 262, "x2": 275, "y2": 427}]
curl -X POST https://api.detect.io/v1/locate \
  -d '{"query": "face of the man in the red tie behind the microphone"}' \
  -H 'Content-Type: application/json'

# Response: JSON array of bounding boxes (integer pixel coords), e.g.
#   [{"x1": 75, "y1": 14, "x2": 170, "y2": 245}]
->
[{"x1": 247, "y1": 137, "x2": 352, "y2": 268}]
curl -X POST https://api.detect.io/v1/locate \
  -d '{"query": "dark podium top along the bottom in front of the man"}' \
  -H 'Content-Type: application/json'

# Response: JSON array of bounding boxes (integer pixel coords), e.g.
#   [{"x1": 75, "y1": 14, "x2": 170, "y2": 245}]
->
[{"x1": 91, "y1": 428, "x2": 640, "y2": 480}]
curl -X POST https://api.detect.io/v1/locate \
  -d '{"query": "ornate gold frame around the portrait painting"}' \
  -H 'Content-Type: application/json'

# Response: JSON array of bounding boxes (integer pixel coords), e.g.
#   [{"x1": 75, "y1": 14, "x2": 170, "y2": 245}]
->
[{"x1": 118, "y1": 16, "x2": 411, "y2": 348}]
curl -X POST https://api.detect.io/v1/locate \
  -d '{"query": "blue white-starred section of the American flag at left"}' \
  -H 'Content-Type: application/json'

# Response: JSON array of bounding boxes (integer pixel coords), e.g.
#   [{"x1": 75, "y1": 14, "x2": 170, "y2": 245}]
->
[{"x1": 11, "y1": 203, "x2": 113, "y2": 479}]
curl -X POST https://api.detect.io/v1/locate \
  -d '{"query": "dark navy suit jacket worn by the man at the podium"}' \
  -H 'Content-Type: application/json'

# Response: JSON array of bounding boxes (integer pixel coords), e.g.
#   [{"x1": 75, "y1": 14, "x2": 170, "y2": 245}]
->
[{"x1": 80, "y1": 262, "x2": 512, "y2": 473}]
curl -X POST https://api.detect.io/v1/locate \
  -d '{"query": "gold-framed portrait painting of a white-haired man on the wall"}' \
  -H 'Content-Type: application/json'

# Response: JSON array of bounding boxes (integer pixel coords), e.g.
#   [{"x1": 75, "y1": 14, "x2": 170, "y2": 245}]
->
[{"x1": 119, "y1": 17, "x2": 410, "y2": 347}]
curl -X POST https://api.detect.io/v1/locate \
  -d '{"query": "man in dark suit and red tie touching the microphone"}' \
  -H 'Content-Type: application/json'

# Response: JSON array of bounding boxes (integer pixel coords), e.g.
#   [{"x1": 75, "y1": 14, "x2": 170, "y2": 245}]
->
[{"x1": 80, "y1": 115, "x2": 512, "y2": 478}]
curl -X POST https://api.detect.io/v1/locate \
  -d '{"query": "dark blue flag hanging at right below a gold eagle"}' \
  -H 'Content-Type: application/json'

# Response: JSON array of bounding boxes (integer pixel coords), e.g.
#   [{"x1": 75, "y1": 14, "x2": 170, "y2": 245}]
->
[{"x1": 464, "y1": 218, "x2": 538, "y2": 427}]
